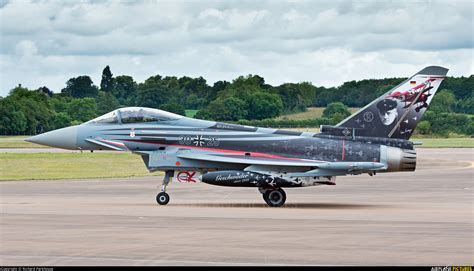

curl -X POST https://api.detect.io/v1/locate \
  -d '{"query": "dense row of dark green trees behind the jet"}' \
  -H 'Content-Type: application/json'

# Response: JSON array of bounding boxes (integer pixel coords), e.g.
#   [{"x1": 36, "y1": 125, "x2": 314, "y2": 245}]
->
[{"x1": 0, "y1": 66, "x2": 474, "y2": 135}]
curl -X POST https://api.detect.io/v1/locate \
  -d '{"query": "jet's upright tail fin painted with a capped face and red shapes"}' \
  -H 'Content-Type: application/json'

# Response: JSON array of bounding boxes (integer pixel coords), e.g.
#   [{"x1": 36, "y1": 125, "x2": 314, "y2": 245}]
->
[{"x1": 336, "y1": 66, "x2": 448, "y2": 140}]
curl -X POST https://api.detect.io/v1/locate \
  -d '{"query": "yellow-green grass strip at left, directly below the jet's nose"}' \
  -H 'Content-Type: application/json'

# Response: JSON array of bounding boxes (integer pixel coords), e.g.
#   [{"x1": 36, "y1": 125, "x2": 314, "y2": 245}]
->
[{"x1": 0, "y1": 152, "x2": 151, "y2": 181}]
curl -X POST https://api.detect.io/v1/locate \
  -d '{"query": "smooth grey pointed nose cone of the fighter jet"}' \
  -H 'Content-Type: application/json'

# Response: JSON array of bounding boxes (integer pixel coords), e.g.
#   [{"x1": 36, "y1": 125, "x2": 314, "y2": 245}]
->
[{"x1": 25, "y1": 126, "x2": 77, "y2": 150}]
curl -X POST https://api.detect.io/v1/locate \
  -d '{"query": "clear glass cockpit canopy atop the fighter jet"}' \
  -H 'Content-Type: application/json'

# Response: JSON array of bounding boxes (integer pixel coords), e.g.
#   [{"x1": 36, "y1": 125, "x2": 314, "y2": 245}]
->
[{"x1": 87, "y1": 107, "x2": 183, "y2": 124}]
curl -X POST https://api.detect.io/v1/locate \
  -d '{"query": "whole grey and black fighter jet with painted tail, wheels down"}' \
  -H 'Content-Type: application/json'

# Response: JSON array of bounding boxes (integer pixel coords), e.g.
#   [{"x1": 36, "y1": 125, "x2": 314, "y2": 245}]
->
[{"x1": 27, "y1": 66, "x2": 448, "y2": 207}]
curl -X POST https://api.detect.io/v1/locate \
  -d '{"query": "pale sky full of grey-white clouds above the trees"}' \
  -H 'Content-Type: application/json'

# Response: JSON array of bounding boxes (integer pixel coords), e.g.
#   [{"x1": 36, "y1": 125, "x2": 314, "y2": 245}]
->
[{"x1": 0, "y1": 0, "x2": 474, "y2": 96}]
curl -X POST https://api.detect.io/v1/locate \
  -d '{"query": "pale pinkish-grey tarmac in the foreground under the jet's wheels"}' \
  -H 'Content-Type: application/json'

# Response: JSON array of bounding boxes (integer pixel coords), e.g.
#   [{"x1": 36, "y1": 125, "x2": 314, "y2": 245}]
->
[{"x1": 0, "y1": 149, "x2": 474, "y2": 266}]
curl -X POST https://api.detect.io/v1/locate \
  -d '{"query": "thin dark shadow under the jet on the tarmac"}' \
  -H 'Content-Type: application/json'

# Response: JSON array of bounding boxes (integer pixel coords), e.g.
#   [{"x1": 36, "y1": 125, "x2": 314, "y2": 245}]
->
[{"x1": 173, "y1": 203, "x2": 386, "y2": 209}]
